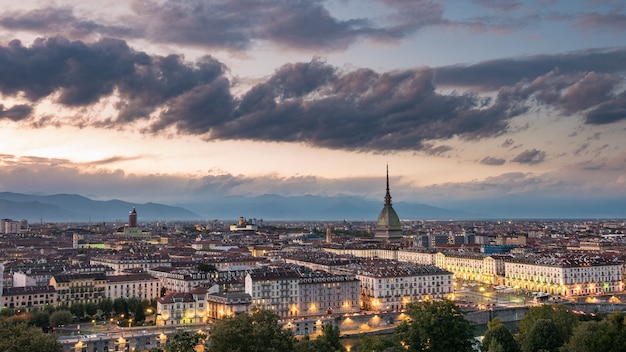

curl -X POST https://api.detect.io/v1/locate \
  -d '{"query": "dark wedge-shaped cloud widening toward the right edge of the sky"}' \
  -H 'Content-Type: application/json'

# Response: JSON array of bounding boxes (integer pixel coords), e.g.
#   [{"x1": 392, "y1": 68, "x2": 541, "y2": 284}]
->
[{"x1": 435, "y1": 49, "x2": 626, "y2": 124}]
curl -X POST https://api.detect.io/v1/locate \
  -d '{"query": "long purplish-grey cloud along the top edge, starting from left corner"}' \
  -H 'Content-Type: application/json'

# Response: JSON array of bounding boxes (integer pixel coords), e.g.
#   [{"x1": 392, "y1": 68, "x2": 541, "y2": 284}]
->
[{"x1": 0, "y1": 0, "x2": 443, "y2": 50}]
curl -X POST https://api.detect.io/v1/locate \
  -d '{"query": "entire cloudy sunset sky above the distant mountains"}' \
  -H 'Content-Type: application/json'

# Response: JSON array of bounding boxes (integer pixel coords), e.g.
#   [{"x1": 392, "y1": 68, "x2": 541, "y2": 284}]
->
[{"x1": 0, "y1": 0, "x2": 626, "y2": 216}]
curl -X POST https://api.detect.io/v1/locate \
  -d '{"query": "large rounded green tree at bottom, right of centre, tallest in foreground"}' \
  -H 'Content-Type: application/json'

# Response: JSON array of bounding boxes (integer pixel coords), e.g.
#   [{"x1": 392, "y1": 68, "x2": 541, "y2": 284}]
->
[{"x1": 394, "y1": 300, "x2": 474, "y2": 352}]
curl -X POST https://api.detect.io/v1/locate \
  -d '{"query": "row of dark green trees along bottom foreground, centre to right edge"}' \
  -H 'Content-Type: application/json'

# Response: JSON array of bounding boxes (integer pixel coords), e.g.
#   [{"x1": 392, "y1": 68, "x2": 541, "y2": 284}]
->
[{"x1": 177, "y1": 300, "x2": 626, "y2": 352}]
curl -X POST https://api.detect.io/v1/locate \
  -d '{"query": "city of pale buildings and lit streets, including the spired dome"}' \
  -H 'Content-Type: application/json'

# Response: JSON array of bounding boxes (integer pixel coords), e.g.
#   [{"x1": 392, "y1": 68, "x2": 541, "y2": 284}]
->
[{"x1": 0, "y1": 170, "x2": 626, "y2": 351}]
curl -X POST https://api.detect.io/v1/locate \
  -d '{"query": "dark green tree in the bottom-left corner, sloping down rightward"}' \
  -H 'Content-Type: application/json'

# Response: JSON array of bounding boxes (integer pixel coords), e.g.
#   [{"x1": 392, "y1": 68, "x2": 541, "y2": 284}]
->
[{"x1": 0, "y1": 318, "x2": 63, "y2": 352}]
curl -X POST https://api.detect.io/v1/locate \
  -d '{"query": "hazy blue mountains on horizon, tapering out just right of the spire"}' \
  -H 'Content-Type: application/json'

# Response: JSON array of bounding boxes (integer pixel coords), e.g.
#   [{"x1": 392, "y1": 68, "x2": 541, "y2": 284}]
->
[{"x1": 0, "y1": 192, "x2": 476, "y2": 222}]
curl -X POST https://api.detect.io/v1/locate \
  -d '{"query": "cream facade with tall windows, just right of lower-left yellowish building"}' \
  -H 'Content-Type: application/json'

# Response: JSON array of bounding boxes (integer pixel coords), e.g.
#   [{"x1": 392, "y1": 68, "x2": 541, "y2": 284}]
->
[{"x1": 106, "y1": 274, "x2": 161, "y2": 300}]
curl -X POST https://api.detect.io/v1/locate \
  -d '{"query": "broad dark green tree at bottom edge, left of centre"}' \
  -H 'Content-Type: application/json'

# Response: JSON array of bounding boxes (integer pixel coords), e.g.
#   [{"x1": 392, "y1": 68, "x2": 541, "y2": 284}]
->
[{"x1": 209, "y1": 310, "x2": 295, "y2": 352}]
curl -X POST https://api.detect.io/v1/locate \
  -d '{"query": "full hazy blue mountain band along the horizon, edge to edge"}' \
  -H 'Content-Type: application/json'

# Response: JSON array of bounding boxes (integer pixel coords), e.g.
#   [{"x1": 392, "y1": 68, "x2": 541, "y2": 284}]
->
[{"x1": 0, "y1": 192, "x2": 626, "y2": 222}]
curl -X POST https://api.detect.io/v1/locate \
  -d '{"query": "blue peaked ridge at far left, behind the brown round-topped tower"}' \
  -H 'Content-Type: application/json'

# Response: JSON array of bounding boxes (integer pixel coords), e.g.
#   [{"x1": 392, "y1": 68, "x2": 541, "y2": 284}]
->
[{"x1": 0, "y1": 192, "x2": 200, "y2": 222}]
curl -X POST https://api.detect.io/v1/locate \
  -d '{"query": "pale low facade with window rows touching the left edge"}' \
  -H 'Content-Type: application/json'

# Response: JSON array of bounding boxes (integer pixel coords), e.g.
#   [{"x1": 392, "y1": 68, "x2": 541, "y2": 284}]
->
[{"x1": 0, "y1": 286, "x2": 57, "y2": 310}]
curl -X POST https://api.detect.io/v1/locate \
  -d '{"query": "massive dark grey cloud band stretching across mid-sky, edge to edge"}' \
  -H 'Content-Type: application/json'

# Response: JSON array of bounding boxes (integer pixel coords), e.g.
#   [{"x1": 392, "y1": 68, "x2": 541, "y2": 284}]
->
[{"x1": 0, "y1": 37, "x2": 626, "y2": 153}]
